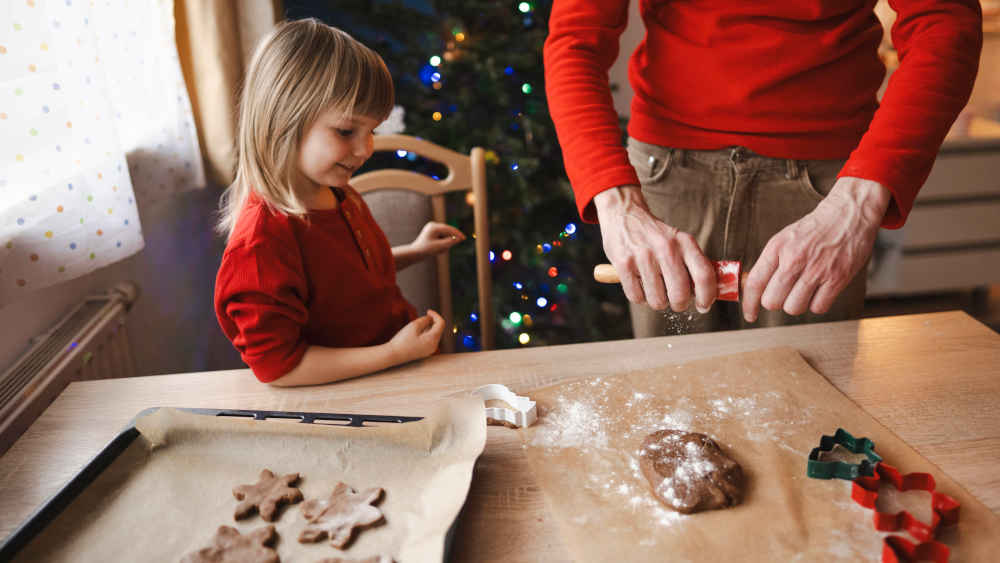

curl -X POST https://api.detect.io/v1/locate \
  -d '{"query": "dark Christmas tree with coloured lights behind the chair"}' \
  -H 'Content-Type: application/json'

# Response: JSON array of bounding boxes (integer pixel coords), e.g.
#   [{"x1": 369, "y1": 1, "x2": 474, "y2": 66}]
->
[{"x1": 285, "y1": 0, "x2": 631, "y2": 350}]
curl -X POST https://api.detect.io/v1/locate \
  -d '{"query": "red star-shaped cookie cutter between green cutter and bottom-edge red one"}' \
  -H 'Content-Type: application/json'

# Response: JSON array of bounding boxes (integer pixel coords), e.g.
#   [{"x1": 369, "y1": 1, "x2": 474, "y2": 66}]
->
[{"x1": 851, "y1": 463, "x2": 961, "y2": 542}]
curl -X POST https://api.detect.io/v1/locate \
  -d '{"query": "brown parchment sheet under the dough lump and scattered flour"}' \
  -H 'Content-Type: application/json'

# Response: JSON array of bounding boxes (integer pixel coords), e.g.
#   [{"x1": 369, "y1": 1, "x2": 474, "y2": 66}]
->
[{"x1": 522, "y1": 348, "x2": 1000, "y2": 562}]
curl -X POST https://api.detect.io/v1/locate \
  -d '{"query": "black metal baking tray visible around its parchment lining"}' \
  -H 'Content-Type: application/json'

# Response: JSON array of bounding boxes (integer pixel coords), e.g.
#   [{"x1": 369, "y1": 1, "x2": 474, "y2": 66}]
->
[{"x1": 0, "y1": 407, "x2": 476, "y2": 561}]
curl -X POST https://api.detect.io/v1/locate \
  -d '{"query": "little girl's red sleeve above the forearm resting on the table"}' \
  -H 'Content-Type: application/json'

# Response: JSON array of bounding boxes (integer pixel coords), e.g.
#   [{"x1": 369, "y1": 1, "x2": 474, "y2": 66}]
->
[{"x1": 215, "y1": 238, "x2": 309, "y2": 383}]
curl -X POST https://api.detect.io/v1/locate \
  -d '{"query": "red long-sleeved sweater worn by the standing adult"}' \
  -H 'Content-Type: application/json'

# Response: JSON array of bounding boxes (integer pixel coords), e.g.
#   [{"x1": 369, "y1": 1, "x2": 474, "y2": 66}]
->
[{"x1": 545, "y1": 0, "x2": 982, "y2": 228}]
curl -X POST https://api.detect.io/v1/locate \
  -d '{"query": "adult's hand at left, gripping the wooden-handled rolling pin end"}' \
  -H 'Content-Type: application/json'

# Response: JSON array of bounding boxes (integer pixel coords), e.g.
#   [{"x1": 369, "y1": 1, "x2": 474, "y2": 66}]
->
[{"x1": 593, "y1": 186, "x2": 718, "y2": 313}]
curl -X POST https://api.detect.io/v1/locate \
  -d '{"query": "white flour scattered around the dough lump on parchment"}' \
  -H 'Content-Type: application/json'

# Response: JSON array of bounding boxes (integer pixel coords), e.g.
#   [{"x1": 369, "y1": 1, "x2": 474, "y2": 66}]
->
[{"x1": 529, "y1": 375, "x2": 810, "y2": 526}]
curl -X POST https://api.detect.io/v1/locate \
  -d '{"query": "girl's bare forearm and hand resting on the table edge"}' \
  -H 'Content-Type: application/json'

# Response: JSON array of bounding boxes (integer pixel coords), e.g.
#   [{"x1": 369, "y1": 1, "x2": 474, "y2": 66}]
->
[{"x1": 269, "y1": 311, "x2": 444, "y2": 387}]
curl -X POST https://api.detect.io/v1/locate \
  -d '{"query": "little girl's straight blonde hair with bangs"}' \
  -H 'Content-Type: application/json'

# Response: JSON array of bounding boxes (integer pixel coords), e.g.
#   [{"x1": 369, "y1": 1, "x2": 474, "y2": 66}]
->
[{"x1": 216, "y1": 18, "x2": 394, "y2": 238}]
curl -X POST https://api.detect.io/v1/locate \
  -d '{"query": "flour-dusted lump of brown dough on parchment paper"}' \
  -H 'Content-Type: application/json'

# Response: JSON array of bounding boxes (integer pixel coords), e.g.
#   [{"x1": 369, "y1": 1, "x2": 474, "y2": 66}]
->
[{"x1": 639, "y1": 430, "x2": 743, "y2": 514}]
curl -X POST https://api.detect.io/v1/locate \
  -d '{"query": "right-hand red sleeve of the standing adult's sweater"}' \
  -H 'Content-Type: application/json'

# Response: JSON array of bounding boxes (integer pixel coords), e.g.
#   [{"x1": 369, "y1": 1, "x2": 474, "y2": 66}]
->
[{"x1": 840, "y1": 0, "x2": 983, "y2": 229}]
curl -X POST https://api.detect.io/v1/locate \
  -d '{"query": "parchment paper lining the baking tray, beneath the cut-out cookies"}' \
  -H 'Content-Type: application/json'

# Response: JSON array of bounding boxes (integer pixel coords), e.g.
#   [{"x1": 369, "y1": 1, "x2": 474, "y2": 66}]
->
[{"x1": 17, "y1": 398, "x2": 486, "y2": 563}]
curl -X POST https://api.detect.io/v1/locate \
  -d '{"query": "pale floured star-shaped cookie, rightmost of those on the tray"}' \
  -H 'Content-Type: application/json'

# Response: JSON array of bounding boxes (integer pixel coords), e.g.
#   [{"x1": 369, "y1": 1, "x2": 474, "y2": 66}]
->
[{"x1": 299, "y1": 483, "x2": 382, "y2": 549}]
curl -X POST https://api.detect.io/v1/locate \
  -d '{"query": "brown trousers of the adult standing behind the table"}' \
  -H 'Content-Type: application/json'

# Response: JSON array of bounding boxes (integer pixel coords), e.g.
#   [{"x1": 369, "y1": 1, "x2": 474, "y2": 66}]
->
[{"x1": 628, "y1": 139, "x2": 866, "y2": 338}]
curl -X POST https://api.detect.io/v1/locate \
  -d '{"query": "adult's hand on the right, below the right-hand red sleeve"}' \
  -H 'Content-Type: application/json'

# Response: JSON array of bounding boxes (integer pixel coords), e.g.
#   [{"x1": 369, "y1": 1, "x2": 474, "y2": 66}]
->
[{"x1": 743, "y1": 177, "x2": 891, "y2": 323}]
